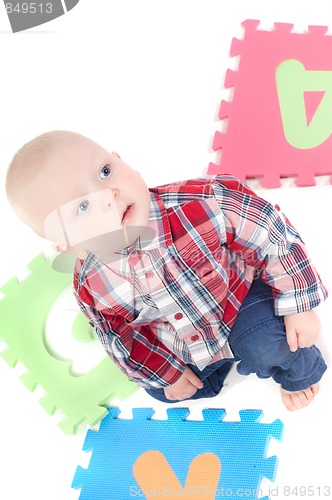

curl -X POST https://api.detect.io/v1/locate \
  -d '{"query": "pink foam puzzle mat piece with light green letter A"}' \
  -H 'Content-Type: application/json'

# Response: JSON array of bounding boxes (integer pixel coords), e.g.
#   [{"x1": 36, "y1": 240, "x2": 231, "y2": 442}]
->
[{"x1": 208, "y1": 20, "x2": 332, "y2": 187}]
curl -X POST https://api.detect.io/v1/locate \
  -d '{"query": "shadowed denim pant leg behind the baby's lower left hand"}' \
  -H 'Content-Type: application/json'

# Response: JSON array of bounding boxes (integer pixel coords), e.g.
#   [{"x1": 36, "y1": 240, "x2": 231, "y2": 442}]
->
[{"x1": 145, "y1": 359, "x2": 233, "y2": 403}]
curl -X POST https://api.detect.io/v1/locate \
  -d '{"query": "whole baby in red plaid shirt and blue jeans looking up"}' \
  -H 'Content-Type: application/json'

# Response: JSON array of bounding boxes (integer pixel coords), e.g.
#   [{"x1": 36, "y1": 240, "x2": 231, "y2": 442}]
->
[{"x1": 6, "y1": 131, "x2": 327, "y2": 410}]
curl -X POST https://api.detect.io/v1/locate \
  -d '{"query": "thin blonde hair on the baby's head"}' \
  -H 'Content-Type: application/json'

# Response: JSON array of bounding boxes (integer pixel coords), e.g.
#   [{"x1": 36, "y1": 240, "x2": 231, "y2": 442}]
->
[{"x1": 6, "y1": 130, "x2": 82, "y2": 237}]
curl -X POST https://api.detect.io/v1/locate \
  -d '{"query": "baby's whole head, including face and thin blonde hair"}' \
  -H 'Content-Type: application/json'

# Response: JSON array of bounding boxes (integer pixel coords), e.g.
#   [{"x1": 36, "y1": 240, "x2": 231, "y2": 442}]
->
[{"x1": 6, "y1": 130, "x2": 151, "y2": 257}]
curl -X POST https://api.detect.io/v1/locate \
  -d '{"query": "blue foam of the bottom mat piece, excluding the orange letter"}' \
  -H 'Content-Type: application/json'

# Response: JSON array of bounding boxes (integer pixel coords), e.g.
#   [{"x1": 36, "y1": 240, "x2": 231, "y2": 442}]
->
[{"x1": 72, "y1": 408, "x2": 283, "y2": 500}]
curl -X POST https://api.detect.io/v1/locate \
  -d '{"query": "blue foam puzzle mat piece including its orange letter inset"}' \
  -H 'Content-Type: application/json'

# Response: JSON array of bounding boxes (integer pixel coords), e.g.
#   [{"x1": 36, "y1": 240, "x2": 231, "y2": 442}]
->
[{"x1": 72, "y1": 408, "x2": 283, "y2": 500}]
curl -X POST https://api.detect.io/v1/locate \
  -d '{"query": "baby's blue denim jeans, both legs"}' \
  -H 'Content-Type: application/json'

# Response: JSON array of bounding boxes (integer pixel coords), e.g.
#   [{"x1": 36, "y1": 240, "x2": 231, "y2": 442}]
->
[{"x1": 146, "y1": 278, "x2": 327, "y2": 403}]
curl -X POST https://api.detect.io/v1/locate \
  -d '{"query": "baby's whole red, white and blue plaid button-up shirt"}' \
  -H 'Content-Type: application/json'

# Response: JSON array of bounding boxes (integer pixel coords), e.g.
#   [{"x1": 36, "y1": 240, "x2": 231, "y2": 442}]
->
[{"x1": 73, "y1": 176, "x2": 327, "y2": 388}]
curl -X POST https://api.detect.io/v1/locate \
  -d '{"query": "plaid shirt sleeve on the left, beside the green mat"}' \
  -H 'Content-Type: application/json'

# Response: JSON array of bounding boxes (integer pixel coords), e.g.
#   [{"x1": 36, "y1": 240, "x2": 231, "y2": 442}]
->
[{"x1": 74, "y1": 289, "x2": 185, "y2": 389}]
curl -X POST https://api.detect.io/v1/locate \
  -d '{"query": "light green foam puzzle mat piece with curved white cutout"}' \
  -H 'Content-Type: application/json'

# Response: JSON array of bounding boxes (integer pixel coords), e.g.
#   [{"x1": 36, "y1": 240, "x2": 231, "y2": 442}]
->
[{"x1": 0, "y1": 255, "x2": 137, "y2": 434}]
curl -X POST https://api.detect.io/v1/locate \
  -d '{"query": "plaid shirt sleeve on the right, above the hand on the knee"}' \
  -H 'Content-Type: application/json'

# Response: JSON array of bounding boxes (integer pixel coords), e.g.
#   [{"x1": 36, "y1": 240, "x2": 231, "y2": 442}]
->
[{"x1": 214, "y1": 178, "x2": 327, "y2": 316}]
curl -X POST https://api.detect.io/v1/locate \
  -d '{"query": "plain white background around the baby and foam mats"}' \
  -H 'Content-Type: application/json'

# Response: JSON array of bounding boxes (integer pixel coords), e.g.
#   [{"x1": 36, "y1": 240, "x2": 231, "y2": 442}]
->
[{"x1": 0, "y1": 0, "x2": 332, "y2": 500}]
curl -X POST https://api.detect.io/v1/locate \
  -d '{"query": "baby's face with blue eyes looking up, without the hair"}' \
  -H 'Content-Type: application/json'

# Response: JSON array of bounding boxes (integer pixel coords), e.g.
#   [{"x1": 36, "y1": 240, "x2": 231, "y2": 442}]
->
[{"x1": 37, "y1": 137, "x2": 151, "y2": 258}]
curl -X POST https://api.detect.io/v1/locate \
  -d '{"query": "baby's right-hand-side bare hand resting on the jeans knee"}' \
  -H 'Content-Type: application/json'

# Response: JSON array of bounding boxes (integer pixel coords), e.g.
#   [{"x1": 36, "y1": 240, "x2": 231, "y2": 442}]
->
[{"x1": 284, "y1": 311, "x2": 320, "y2": 352}]
